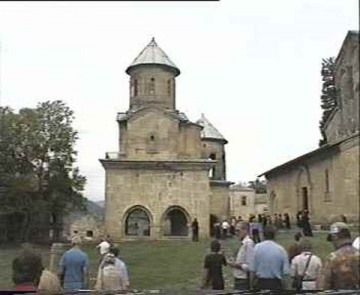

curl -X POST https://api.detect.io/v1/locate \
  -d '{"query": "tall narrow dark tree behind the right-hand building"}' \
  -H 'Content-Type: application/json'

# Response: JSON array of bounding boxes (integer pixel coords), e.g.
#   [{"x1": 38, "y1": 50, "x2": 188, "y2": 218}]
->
[{"x1": 319, "y1": 57, "x2": 337, "y2": 146}]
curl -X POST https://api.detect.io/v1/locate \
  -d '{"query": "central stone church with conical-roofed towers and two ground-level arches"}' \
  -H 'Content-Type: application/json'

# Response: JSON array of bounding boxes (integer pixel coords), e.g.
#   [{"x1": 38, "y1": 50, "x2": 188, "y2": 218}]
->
[{"x1": 100, "y1": 39, "x2": 232, "y2": 240}]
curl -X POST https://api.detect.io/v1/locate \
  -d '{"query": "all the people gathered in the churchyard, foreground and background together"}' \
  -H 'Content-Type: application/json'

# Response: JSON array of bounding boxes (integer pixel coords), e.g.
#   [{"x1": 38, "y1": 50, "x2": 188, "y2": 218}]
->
[{"x1": 12, "y1": 212, "x2": 360, "y2": 294}]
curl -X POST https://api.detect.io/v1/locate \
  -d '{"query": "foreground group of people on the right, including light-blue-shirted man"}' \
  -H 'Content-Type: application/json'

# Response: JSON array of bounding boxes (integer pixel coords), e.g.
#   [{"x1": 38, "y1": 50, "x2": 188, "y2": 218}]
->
[{"x1": 202, "y1": 221, "x2": 360, "y2": 291}]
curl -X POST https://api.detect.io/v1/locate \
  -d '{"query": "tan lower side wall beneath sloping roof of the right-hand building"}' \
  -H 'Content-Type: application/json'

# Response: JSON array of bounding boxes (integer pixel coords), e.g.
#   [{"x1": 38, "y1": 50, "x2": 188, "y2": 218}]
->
[{"x1": 268, "y1": 136, "x2": 360, "y2": 222}]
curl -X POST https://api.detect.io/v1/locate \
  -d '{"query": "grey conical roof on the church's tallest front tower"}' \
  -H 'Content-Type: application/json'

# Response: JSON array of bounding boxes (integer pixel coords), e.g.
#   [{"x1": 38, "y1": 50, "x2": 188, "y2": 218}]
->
[{"x1": 126, "y1": 38, "x2": 180, "y2": 76}]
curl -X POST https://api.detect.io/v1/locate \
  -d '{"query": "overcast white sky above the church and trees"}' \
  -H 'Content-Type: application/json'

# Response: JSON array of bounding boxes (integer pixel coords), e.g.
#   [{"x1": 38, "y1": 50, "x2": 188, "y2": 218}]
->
[{"x1": 0, "y1": 0, "x2": 359, "y2": 200}]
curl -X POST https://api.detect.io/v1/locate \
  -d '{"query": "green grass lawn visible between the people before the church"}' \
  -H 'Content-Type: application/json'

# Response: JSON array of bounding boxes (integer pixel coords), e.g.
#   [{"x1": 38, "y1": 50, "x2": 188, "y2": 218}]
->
[{"x1": 0, "y1": 232, "x2": 333, "y2": 291}]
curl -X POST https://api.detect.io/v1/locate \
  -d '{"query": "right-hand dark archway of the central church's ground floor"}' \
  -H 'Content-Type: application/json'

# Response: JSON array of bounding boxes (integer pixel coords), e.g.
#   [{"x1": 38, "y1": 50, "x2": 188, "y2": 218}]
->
[{"x1": 162, "y1": 206, "x2": 190, "y2": 237}]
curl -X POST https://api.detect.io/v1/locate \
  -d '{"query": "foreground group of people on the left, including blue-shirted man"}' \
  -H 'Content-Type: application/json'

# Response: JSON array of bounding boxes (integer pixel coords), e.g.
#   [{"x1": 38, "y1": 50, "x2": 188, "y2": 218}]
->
[{"x1": 12, "y1": 235, "x2": 130, "y2": 294}]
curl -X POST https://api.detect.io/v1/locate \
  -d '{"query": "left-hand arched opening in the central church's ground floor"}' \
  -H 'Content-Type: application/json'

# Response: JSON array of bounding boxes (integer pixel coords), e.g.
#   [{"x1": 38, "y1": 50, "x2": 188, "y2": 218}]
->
[{"x1": 125, "y1": 207, "x2": 150, "y2": 237}]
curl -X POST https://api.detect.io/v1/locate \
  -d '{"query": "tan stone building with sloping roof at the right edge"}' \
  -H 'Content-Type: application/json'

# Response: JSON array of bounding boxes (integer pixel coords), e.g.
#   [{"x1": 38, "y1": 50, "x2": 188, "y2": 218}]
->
[{"x1": 260, "y1": 31, "x2": 360, "y2": 222}]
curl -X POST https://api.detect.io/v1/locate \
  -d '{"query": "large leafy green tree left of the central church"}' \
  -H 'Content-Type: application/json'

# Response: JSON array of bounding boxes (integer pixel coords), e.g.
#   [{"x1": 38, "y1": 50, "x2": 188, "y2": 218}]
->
[{"x1": 0, "y1": 101, "x2": 86, "y2": 240}]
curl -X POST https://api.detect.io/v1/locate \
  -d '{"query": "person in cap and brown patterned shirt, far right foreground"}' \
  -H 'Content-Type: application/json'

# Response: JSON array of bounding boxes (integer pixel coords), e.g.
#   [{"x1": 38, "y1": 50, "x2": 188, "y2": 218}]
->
[{"x1": 317, "y1": 222, "x2": 360, "y2": 290}]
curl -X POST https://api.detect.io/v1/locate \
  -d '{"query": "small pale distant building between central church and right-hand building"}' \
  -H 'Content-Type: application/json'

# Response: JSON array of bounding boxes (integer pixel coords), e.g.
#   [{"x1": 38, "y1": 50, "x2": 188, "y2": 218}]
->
[{"x1": 230, "y1": 184, "x2": 268, "y2": 220}]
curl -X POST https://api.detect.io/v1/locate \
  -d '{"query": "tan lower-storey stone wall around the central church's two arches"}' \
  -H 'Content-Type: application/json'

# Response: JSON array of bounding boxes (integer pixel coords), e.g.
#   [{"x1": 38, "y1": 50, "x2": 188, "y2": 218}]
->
[{"x1": 105, "y1": 168, "x2": 210, "y2": 239}]
